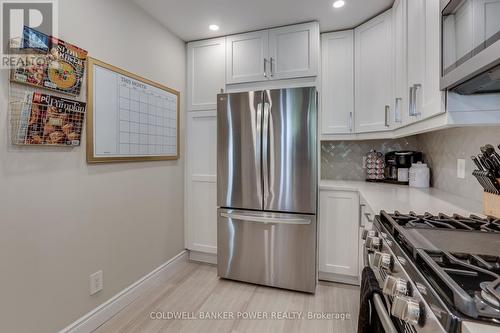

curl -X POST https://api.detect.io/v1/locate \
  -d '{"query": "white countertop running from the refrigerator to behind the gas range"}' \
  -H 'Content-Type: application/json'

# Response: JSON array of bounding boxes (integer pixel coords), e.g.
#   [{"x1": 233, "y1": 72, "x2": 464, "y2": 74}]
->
[{"x1": 319, "y1": 180, "x2": 484, "y2": 216}]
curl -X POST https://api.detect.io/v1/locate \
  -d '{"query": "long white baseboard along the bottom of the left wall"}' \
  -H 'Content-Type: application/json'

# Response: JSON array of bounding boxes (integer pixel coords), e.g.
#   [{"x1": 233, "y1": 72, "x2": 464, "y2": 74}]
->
[{"x1": 59, "y1": 250, "x2": 188, "y2": 333}]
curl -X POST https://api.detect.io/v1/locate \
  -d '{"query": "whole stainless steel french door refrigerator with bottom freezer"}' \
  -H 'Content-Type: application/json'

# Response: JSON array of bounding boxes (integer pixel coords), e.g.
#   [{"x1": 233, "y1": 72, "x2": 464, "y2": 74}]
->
[{"x1": 217, "y1": 87, "x2": 317, "y2": 293}]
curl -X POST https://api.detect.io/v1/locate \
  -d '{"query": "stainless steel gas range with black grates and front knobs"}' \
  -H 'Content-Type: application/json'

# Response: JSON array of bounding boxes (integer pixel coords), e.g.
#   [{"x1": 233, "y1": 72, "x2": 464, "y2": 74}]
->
[{"x1": 364, "y1": 211, "x2": 500, "y2": 333}]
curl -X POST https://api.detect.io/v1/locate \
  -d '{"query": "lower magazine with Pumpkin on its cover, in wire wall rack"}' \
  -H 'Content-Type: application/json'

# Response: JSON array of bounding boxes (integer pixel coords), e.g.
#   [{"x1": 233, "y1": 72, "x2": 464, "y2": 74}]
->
[{"x1": 26, "y1": 93, "x2": 86, "y2": 146}]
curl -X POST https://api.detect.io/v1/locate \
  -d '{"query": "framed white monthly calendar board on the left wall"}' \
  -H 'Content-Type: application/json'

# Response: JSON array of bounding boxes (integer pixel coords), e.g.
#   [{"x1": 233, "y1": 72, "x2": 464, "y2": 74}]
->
[{"x1": 87, "y1": 59, "x2": 179, "y2": 163}]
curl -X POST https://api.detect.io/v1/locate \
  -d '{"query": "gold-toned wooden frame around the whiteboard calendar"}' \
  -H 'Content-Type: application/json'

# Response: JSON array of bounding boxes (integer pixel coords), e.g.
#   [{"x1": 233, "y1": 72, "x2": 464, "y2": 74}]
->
[{"x1": 86, "y1": 57, "x2": 180, "y2": 163}]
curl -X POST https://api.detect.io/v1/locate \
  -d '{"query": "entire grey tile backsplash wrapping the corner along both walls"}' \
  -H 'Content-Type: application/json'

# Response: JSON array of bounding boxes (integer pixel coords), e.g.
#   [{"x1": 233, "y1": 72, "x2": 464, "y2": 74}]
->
[{"x1": 321, "y1": 126, "x2": 500, "y2": 201}]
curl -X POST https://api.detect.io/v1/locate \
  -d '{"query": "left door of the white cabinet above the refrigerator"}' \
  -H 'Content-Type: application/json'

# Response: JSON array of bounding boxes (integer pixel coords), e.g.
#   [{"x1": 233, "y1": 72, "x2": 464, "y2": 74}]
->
[{"x1": 226, "y1": 30, "x2": 270, "y2": 84}]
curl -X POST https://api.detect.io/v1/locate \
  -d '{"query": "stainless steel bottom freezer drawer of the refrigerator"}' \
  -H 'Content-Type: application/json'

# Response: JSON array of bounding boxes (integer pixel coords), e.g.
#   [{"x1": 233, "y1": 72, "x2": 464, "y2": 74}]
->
[{"x1": 217, "y1": 209, "x2": 317, "y2": 293}]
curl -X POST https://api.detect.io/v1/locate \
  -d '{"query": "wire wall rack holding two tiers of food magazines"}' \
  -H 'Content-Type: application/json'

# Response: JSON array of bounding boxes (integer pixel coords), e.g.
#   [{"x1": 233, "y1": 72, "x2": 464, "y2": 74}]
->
[{"x1": 9, "y1": 27, "x2": 87, "y2": 147}]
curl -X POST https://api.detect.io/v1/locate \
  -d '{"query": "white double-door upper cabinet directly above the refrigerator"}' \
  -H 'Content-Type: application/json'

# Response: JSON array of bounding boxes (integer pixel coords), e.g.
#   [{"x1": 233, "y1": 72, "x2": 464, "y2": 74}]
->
[{"x1": 226, "y1": 22, "x2": 319, "y2": 84}]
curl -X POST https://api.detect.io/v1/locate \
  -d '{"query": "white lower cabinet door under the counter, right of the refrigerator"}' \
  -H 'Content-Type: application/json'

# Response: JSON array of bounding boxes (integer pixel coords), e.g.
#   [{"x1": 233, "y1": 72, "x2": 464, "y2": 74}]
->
[{"x1": 319, "y1": 191, "x2": 359, "y2": 279}]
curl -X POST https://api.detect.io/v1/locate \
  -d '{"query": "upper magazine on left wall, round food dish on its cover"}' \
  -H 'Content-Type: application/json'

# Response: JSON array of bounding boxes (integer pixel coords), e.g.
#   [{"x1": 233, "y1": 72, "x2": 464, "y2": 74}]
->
[{"x1": 11, "y1": 27, "x2": 87, "y2": 95}]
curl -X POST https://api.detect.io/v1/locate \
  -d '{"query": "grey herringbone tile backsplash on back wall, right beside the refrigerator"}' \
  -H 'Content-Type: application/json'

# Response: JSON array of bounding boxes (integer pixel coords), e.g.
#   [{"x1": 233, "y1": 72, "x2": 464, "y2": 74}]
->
[{"x1": 321, "y1": 136, "x2": 418, "y2": 180}]
